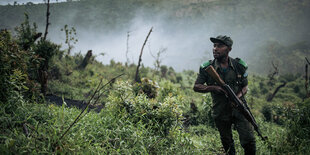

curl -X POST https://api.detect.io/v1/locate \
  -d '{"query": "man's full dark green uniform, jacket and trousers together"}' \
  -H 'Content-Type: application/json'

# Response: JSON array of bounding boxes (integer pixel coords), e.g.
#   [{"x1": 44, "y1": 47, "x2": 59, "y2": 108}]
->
[{"x1": 195, "y1": 57, "x2": 256, "y2": 154}]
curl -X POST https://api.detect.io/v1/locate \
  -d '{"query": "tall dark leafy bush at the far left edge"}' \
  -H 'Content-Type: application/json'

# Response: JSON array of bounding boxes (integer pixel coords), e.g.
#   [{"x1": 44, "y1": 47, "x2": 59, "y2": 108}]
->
[{"x1": 0, "y1": 30, "x2": 35, "y2": 103}]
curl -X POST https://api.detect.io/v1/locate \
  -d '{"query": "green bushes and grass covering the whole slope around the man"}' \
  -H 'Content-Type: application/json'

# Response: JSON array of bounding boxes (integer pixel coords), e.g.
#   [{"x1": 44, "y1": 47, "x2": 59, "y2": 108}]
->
[{"x1": 0, "y1": 1, "x2": 310, "y2": 154}]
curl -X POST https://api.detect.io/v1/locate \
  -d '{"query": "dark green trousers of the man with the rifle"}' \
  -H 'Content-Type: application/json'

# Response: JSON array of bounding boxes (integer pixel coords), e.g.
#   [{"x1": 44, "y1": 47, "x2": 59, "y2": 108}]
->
[{"x1": 215, "y1": 109, "x2": 256, "y2": 155}]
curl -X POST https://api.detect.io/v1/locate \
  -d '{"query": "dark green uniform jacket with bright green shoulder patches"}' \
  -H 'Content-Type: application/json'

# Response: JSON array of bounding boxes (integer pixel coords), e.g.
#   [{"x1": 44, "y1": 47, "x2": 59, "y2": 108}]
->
[{"x1": 196, "y1": 57, "x2": 248, "y2": 120}]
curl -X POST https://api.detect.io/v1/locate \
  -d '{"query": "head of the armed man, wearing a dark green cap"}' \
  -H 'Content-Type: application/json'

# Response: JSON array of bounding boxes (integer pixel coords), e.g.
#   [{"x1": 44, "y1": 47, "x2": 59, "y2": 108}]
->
[{"x1": 210, "y1": 35, "x2": 233, "y2": 59}]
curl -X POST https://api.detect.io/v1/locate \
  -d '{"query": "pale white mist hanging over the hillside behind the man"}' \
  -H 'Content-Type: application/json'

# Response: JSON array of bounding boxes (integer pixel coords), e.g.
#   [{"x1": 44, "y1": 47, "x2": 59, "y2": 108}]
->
[{"x1": 1, "y1": 0, "x2": 310, "y2": 71}]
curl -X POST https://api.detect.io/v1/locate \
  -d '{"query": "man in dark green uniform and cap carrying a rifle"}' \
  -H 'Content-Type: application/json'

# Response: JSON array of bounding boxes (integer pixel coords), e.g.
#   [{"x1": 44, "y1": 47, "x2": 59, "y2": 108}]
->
[{"x1": 194, "y1": 35, "x2": 256, "y2": 155}]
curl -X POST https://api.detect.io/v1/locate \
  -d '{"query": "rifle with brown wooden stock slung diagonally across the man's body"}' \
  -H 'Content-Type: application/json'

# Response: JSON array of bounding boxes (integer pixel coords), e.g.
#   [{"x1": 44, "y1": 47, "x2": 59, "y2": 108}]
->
[{"x1": 206, "y1": 65, "x2": 267, "y2": 141}]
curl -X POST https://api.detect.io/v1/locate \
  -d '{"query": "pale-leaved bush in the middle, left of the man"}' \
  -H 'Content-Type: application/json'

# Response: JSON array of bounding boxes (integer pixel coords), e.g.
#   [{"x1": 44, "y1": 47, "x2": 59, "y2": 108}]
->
[{"x1": 107, "y1": 82, "x2": 182, "y2": 135}]
